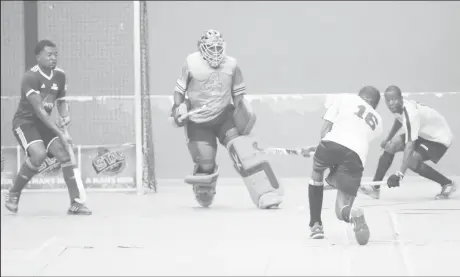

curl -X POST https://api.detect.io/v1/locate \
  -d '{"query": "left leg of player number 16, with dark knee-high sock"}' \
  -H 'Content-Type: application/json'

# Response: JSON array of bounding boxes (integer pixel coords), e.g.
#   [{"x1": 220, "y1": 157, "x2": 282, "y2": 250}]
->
[{"x1": 308, "y1": 141, "x2": 343, "y2": 239}]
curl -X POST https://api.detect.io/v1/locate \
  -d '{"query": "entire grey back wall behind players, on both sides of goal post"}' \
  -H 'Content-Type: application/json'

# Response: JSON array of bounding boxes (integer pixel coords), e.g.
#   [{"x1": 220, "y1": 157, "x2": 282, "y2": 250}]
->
[{"x1": 1, "y1": 1, "x2": 460, "y2": 178}]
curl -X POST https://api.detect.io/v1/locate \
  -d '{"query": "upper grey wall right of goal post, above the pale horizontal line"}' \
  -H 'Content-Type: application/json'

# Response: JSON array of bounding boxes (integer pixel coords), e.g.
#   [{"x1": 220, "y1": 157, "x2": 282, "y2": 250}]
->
[{"x1": 148, "y1": 1, "x2": 460, "y2": 94}]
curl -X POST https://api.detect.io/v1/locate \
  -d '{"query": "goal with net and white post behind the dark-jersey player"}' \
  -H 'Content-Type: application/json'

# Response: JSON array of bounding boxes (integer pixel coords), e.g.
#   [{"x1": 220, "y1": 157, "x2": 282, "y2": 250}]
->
[{"x1": 1, "y1": 1, "x2": 157, "y2": 193}]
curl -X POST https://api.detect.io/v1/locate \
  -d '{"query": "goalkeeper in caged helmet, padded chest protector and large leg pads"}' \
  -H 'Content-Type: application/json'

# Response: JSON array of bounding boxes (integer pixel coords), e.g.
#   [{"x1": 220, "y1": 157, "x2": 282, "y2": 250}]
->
[{"x1": 171, "y1": 29, "x2": 282, "y2": 209}]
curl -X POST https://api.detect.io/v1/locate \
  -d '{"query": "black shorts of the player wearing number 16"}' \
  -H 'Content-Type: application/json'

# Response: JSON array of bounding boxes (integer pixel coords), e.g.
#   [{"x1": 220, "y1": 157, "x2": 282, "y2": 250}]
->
[{"x1": 313, "y1": 141, "x2": 364, "y2": 196}]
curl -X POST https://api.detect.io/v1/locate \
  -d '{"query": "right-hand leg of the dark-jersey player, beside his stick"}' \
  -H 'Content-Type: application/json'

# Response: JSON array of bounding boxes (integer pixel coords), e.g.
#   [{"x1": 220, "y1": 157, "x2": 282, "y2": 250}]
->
[{"x1": 45, "y1": 133, "x2": 92, "y2": 215}]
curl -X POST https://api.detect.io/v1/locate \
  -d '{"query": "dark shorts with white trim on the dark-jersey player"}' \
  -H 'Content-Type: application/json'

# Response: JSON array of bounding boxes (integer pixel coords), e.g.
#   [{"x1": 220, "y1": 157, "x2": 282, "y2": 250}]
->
[{"x1": 13, "y1": 121, "x2": 59, "y2": 156}]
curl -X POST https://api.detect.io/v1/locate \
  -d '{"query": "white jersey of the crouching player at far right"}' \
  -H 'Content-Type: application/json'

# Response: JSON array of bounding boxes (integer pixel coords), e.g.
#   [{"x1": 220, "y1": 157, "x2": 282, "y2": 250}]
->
[{"x1": 395, "y1": 99, "x2": 454, "y2": 147}]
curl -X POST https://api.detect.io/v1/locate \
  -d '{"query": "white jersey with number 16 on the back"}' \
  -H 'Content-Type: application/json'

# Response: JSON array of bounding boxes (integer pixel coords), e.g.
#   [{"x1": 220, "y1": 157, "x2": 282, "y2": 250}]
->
[{"x1": 323, "y1": 94, "x2": 383, "y2": 166}]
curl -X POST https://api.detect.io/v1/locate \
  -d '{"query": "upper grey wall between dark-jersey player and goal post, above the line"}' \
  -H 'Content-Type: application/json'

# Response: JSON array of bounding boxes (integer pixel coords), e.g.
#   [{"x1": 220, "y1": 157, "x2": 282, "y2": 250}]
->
[{"x1": 38, "y1": 1, "x2": 134, "y2": 95}]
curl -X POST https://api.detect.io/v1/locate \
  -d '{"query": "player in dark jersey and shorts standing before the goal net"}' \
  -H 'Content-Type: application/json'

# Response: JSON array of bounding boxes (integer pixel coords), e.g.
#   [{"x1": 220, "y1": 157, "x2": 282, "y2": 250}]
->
[{"x1": 5, "y1": 40, "x2": 91, "y2": 215}]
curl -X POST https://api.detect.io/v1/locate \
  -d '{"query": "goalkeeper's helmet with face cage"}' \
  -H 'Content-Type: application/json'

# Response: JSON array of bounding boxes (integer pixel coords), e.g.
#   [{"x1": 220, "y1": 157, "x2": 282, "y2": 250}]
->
[{"x1": 198, "y1": 29, "x2": 225, "y2": 67}]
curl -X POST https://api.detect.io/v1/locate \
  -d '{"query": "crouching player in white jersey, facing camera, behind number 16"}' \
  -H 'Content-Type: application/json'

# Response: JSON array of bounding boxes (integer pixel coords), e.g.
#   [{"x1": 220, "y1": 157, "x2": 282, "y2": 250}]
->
[{"x1": 361, "y1": 86, "x2": 457, "y2": 199}]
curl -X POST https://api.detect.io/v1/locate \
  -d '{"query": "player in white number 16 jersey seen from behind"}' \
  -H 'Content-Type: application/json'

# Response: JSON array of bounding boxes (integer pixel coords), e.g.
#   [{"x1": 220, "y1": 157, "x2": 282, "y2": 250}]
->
[{"x1": 308, "y1": 86, "x2": 383, "y2": 245}]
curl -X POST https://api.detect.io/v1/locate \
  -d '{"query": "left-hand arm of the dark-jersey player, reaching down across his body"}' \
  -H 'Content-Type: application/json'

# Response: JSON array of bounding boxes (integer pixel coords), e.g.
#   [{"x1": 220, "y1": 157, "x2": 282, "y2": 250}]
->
[{"x1": 21, "y1": 75, "x2": 62, "y2": 136}]
